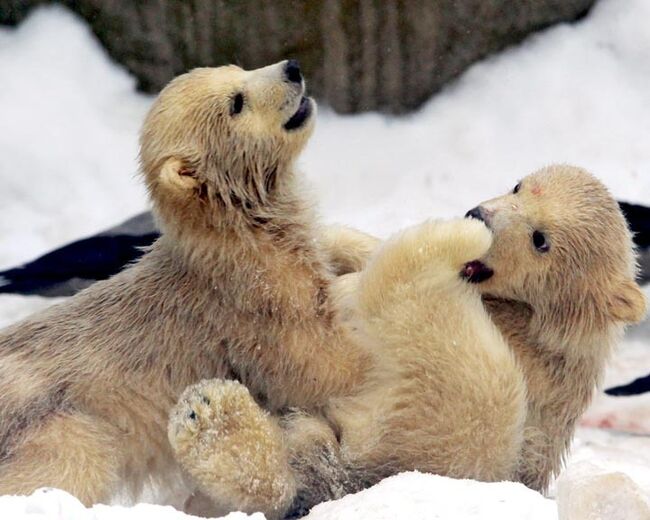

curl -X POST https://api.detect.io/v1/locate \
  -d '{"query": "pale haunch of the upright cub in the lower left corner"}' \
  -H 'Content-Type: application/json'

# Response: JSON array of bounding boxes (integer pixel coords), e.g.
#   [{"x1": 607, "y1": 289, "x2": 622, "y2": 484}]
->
[{"x1": 0, "y1": 412, "x2": 122, "y2": 505}]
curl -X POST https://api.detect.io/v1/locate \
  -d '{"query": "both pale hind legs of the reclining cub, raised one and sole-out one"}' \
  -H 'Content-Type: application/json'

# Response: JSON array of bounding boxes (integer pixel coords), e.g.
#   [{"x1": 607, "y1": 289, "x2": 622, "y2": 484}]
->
[{"x1": 169, "y1": 220, "x2": 525, "y2": 517}]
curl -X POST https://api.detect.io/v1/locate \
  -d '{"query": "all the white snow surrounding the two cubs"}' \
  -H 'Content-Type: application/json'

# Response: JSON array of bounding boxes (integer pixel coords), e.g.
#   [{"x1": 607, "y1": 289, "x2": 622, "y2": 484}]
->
[{"x1": 0, "y1": 0, "x2": 650, "y2": 520}]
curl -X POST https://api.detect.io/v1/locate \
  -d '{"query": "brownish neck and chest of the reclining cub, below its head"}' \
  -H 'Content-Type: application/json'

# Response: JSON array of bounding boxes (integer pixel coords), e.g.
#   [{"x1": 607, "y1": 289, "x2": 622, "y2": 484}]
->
[{"x1": 483, "y1": 296, "x2": 615, "y2": 491}]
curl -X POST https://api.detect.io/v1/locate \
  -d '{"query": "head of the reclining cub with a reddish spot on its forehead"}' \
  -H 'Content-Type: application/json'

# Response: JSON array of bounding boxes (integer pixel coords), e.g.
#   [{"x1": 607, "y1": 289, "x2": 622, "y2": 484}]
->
[{"x1": 466, "y1": 166, "x2": 645, "y2": 338}]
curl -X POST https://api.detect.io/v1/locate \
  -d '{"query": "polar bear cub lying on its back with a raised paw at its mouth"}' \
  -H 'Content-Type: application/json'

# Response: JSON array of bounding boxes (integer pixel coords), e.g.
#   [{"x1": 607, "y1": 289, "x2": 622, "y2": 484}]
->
[{"x1": 170, "y1": 166, "x2": 645, "y2": 516}]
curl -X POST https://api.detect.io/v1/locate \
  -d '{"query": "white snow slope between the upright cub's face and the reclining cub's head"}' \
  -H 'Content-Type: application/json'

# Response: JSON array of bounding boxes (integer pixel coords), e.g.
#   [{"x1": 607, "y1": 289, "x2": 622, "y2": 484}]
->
[{"x1": 303, "y1": 0, "x2": 650, "y2": 235}]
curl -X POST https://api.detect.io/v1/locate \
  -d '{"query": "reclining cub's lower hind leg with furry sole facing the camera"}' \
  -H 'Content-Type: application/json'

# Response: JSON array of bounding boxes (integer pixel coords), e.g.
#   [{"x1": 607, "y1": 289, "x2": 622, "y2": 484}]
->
[{"x1": 169, "y1": 380, "x2": 360, "y2": 519}]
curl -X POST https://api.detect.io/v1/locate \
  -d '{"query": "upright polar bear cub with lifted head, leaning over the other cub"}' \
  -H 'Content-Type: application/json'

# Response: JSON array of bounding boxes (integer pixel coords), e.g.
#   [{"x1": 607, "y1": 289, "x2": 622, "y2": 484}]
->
[{"x1": 0, "y1": 63, "x2": 368, "y2": 504}]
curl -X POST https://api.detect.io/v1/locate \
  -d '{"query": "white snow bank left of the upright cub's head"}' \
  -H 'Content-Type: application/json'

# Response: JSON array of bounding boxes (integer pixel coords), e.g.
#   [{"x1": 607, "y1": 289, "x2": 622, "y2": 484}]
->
[{"x1": 0, "y1": 6, "x2": 150, "y2": 267}]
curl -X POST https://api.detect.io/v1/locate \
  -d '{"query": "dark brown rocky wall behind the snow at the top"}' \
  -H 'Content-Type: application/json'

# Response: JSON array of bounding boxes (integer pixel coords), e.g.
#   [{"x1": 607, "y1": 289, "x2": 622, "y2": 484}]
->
[{"x1": 0, "y1": 0, "x2": 595, "y2": 113}]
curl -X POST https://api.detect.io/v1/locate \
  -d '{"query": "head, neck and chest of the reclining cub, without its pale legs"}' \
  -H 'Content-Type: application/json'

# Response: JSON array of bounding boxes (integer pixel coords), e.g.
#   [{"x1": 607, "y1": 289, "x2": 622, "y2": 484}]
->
[{"x1": 470, "y1": 165, "x2": 646, "y2": 491}]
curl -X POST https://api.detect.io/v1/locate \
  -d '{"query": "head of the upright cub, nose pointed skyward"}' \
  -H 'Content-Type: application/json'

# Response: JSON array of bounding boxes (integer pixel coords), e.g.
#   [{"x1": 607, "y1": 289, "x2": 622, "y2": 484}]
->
[{"x1": 140, "y1": 60, "x2": 316, "y2": 232}]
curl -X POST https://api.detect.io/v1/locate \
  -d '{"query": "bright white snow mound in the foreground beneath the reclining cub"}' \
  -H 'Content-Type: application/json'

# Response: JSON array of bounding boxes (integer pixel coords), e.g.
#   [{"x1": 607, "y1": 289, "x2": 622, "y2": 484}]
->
[{"x1": 306, "y1": 472, "x2": 557, "y2": 520}]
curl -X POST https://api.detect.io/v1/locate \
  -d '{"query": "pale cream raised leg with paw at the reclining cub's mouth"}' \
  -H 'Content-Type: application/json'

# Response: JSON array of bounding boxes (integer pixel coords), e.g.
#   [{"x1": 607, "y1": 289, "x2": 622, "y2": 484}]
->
[{"x1": 356, "y1": 220, "x2": 526, "y2": 481}]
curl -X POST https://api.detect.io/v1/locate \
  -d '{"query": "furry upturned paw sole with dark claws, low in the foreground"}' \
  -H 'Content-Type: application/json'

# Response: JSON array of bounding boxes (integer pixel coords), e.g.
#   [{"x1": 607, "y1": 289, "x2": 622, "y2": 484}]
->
[{"x1": 168, "y1": 379, "x2": 294, "y2": 517}]
